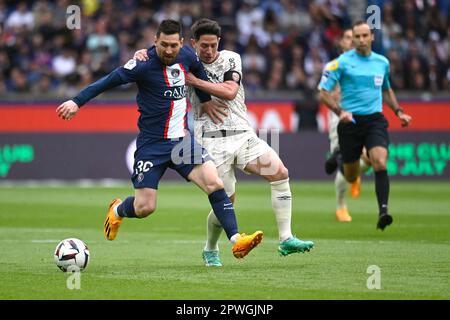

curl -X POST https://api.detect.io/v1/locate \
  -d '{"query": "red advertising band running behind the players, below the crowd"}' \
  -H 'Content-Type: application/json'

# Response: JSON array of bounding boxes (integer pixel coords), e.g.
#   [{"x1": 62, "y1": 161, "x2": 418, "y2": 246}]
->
[{"x1": 0, "y1": 102, "x2": 450, "y2": 133}]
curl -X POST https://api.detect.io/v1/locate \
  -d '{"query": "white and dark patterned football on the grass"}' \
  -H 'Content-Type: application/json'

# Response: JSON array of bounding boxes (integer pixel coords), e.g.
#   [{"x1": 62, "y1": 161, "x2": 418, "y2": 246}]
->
[{"x1": 54, "y1": 238, "x2": 89, "y2": 272}]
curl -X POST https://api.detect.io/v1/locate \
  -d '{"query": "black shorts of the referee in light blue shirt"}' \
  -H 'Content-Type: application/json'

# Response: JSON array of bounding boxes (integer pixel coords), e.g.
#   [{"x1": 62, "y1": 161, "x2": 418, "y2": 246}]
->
[{"x1": 337, "y1": 112, "x2": 389, "y2": 163}]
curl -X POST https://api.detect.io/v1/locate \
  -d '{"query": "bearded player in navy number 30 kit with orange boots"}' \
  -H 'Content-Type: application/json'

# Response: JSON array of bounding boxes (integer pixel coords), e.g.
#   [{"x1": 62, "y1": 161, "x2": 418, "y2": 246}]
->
[{"x1": 56, "y1": 20, "x2": 263, "y2": 258}]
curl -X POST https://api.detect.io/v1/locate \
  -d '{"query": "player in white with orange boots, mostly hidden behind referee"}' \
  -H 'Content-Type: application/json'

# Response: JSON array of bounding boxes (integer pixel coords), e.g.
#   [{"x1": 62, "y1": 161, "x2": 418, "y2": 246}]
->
[{"x1": 318, "y1": 28, "x2": 371, "y2": 222}]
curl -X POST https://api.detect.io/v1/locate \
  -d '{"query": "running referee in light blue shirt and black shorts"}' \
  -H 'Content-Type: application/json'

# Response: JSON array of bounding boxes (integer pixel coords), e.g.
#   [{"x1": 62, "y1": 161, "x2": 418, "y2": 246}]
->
[{"x1": 320, "y1": 21, "x2": 411, "y2": 230}]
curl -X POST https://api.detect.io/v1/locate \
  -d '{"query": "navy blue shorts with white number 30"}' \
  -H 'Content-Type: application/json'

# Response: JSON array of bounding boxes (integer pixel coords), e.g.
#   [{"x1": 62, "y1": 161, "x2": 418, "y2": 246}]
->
[{"x1": 131, "y1": 135, "x2": 212, "y2": 189}]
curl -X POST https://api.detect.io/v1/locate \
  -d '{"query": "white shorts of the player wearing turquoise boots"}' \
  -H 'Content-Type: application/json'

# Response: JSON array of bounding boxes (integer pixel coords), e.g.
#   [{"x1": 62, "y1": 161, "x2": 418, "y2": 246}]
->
[{"x1": 202, "y1": 131, "x2": 273, "y2": 196}]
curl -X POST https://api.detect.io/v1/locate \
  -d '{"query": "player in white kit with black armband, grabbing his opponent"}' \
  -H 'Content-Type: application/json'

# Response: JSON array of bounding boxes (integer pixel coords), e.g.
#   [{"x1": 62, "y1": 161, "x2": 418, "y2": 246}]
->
[{"x1": 135, "y1": 19, "x2": 314, "y2": 266}]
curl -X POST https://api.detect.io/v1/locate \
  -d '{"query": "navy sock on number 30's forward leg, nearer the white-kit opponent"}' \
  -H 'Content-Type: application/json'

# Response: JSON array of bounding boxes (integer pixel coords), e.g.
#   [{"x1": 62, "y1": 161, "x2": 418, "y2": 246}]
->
[{"x1": 208, "y1": 189, "x2": 238, "y2": 239}]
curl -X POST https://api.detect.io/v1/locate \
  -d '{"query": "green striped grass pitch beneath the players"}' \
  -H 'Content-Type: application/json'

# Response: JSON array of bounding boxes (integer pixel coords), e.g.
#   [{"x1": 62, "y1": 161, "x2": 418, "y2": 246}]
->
[{"x1": 0, "y1": 179, "x2": 450, "y2": 300}]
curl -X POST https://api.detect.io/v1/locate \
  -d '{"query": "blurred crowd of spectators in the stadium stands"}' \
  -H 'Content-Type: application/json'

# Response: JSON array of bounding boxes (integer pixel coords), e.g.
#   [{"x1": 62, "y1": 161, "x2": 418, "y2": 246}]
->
[{"x1": 0, "y1": 0, "x2": 450, "y2": 95}]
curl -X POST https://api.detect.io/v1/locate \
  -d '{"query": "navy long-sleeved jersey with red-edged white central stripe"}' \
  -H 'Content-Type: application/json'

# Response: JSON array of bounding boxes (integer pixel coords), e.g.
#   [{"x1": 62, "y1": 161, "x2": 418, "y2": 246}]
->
[{"x1": 73, "y1": 47, "x2": 211, "y2": 139}]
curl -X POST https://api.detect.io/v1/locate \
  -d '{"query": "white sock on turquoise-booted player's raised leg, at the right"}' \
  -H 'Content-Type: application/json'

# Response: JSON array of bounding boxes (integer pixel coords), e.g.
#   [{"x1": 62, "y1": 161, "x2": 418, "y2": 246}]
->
[{"x1": 270, "y1": 178, "x2": 292, "y2": 242}]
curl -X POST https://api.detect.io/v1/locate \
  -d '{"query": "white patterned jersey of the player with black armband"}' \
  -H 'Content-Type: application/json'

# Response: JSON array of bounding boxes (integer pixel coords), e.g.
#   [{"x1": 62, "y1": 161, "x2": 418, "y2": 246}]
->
[{"x1": 188, "y1": 50, "x2": 253, "y2": 135}]
